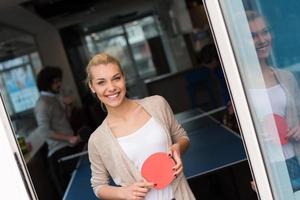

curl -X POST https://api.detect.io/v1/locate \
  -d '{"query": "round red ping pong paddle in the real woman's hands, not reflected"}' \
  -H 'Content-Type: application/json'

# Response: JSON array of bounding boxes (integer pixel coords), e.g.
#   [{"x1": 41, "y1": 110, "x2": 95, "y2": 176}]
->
[{"x1": 141, "y1": 152, "x2": 175, "y2": 189}]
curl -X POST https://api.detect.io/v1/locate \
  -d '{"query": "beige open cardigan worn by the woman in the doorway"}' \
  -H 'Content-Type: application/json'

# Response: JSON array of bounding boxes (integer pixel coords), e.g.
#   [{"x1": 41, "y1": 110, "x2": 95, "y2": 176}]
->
[{"x1": 88, "y1": 96, "x2": 195, "y2": 200}]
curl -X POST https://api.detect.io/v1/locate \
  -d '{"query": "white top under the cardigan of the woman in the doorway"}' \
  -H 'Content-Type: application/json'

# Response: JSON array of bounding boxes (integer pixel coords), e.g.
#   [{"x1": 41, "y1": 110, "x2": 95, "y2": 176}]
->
[{"x1": 117, "y1": 117, "x2": 174, "y2": 200}]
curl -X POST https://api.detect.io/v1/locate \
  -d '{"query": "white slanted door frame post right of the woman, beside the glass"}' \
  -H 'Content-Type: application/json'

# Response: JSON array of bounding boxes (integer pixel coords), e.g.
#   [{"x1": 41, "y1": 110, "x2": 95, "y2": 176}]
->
[{"x1": 203, "y1": 0, "x2": 274, "y2": 200}]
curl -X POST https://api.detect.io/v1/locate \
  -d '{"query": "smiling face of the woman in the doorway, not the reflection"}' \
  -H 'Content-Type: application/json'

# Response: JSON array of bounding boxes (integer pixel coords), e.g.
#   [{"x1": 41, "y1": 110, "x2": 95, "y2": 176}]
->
[{"x1": 89, "y1": 63, "x2": 126, "y2": 109}]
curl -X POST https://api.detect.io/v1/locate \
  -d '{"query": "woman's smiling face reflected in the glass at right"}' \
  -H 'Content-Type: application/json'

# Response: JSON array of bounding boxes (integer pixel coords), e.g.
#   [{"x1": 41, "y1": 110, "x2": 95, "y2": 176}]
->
[{"x1": 249, "y1": 17, "x2": 272, "y2": 60}]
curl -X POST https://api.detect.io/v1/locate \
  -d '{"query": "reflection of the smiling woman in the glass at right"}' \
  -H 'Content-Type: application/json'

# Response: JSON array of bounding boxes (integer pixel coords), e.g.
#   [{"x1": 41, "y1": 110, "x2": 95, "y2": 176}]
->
[{"x1": 246, "y1": 11, "x2": 300, "y2": 194}]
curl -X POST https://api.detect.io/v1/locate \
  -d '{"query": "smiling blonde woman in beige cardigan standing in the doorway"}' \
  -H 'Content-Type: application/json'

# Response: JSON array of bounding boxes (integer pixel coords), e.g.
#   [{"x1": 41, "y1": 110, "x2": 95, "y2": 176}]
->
[{"x1": 86, "y1": 54, "x2": 195, "y2": 200}]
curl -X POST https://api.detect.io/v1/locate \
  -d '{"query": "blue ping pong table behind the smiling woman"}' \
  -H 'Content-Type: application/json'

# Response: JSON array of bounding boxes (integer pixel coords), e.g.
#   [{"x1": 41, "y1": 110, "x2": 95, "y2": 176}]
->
[{"x1": 63, "y1": 109, "x2": 247, "y2": 200}]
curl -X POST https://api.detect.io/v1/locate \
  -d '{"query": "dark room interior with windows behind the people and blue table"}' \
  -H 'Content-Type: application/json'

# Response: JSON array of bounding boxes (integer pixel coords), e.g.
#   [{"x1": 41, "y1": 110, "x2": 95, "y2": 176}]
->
[{"x1": 0, "y1": 0, "x2": 257, "y2": 200}]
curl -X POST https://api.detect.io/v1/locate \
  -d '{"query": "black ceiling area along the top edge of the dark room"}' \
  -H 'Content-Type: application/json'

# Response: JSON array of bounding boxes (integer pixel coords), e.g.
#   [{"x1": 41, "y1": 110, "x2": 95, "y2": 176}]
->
[{"x1": 20, "y1": 0, "x2": 155, "y2": 29}]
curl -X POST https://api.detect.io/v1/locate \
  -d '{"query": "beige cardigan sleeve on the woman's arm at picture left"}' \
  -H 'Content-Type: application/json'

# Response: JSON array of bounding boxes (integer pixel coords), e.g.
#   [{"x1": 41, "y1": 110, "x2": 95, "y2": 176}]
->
[{"x1": 88, "y1": 136, "x2": 109, "y2": 198}]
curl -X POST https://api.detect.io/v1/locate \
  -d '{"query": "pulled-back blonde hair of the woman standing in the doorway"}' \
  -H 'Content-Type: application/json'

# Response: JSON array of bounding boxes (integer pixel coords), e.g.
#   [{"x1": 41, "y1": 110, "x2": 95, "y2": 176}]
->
[{"x1": 85, "y1": 53, "x2": 124, "y2": 84}]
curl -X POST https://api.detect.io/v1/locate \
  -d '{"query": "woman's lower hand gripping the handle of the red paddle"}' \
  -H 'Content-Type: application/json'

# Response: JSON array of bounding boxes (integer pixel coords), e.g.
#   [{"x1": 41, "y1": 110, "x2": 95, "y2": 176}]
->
[{"x1": 120, "y1": 181, "x2": 154, "y2": 200}]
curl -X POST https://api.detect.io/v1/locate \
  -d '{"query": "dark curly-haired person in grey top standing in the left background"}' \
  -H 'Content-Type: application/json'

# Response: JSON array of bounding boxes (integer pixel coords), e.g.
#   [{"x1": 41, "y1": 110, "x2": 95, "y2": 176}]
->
[{"x1": 34, "y1": 66, "x2": 81, "y2": 196}]
